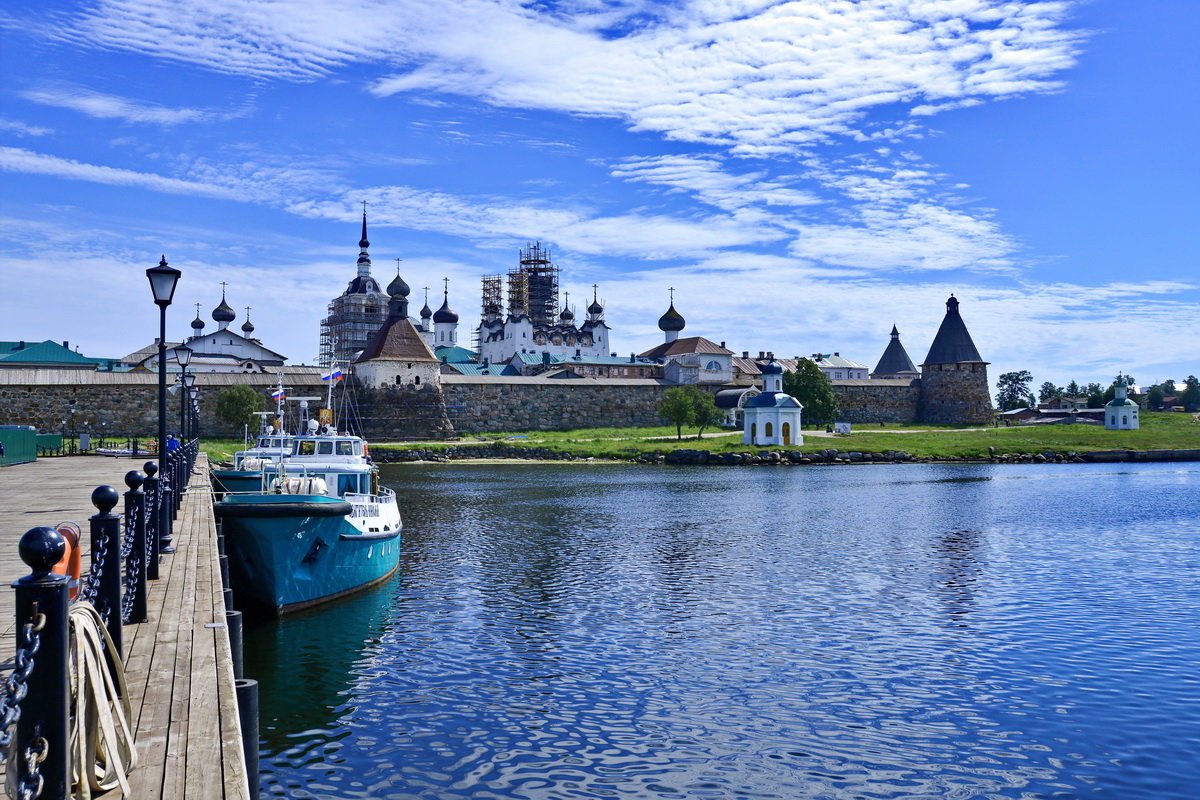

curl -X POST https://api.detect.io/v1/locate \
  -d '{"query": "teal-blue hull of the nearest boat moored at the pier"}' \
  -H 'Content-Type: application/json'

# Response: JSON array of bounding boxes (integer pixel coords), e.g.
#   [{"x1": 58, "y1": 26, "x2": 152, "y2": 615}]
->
[{"x1": 214, "y1": 494, "x2": 400, "y2": 614}]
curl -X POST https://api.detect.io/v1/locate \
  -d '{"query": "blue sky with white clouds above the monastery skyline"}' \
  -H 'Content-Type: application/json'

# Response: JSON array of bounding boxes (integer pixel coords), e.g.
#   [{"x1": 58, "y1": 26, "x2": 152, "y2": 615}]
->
[{"x1": 0, "y1": 0, "x2": 1200, "y2": 383}]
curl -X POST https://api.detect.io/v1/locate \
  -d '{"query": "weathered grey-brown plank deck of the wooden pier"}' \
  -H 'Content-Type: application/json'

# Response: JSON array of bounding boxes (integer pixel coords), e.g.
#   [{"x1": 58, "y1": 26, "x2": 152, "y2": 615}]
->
[{"x1": 0, "y1": 453, "x2": 250, "y2": 800}]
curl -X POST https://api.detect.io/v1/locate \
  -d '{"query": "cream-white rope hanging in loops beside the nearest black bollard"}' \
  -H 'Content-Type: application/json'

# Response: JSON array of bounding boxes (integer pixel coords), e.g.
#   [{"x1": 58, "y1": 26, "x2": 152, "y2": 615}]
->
[{"x1": 70, "y1": 602, "x2": 138, "y2": 800}]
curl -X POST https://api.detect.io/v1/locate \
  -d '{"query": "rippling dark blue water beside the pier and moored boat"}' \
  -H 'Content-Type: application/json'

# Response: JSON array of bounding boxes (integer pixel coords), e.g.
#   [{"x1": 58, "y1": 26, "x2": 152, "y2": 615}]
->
[{"x1": 246, "y1": 464, "x2": 1200, "y2": 800}]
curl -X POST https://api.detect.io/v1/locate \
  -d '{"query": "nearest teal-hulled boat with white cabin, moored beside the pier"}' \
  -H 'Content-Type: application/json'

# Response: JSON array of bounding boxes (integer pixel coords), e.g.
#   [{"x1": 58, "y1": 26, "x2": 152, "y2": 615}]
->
[{"x1": 214, "y1": 422, "x2": 402, "y2": 614}]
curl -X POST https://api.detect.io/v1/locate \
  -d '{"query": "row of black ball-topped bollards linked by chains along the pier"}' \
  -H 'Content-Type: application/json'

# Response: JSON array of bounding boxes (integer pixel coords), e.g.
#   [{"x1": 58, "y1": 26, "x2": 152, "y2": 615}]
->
[{"x1": 0, "y1": 440, "x2": 218, "y2": 800}]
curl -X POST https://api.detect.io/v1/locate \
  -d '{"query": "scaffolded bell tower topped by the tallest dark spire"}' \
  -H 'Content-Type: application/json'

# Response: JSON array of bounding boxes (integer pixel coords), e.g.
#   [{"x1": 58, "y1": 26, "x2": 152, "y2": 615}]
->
[{"x1": 319, "y1": 211, "x2": 388, "y2": 367}]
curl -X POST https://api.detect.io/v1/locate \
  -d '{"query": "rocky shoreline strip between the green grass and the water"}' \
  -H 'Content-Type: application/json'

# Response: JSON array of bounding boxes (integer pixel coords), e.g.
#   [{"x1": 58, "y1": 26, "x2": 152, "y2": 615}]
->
[{"x1": 371, "y1": 444, "x2": 1200, "y2": 467}]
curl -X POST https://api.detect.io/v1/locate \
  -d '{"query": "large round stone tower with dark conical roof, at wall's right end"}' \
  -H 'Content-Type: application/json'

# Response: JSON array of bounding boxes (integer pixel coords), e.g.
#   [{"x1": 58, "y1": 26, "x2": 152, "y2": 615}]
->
[{"x1": 919, "y1": 294, "x2": 992, "y2": 425}]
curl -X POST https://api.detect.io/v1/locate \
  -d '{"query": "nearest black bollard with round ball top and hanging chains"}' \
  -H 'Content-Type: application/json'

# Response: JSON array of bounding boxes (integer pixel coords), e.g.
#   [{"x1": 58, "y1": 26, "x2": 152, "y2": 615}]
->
[{"x1": 10, "y1": 528, "x2": 71, "y2": 798}]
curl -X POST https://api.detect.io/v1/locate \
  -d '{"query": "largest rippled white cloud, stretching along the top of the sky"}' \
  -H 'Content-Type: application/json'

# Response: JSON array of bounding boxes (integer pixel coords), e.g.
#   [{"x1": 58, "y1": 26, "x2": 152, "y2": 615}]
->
[{"x1": 26, "y1": 0, "x2": 1079, "y2": 154}]
